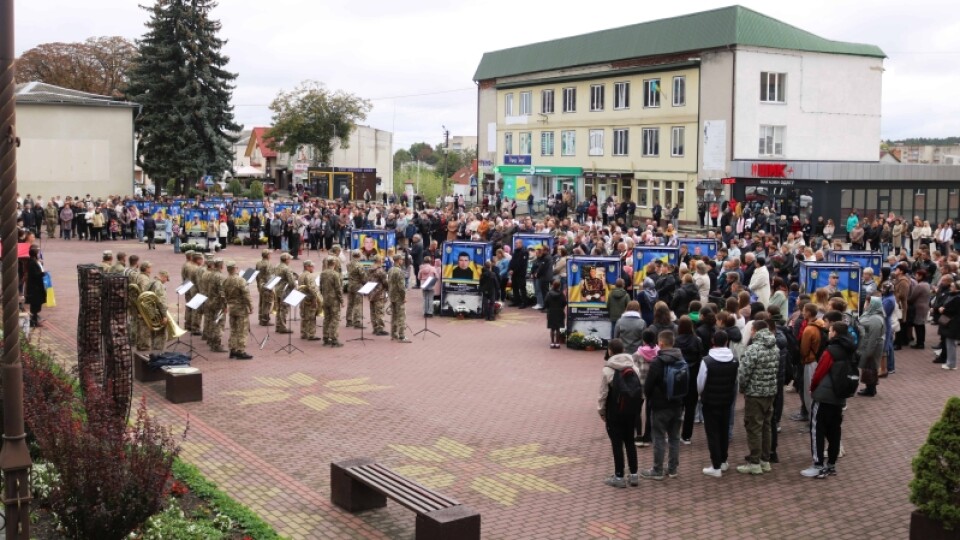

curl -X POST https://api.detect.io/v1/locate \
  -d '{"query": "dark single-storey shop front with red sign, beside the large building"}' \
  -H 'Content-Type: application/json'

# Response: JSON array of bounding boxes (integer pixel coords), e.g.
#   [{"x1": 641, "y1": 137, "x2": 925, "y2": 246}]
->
[{"x1": 725, "y1": 162, "x2": 960, "y2": 223}]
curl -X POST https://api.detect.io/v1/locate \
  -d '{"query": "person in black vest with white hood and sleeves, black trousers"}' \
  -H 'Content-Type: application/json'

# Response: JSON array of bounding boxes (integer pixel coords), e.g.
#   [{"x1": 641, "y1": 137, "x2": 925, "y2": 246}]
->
[{"x1": 697, "y1": 330, "x2": 739, "y2": 478}]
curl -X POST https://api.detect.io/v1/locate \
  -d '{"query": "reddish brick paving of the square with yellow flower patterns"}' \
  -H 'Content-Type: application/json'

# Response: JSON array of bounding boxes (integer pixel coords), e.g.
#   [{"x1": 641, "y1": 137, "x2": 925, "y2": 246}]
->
[{"x1": 32, "y1": 240, "x2": 960, "y2": 539}]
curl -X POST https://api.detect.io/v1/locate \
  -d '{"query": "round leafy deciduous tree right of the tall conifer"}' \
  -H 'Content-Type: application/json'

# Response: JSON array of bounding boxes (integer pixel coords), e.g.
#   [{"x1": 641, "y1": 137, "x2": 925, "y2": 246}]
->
[{"x1": 267, "y1": 81, "x2": 372, "y2": 163}]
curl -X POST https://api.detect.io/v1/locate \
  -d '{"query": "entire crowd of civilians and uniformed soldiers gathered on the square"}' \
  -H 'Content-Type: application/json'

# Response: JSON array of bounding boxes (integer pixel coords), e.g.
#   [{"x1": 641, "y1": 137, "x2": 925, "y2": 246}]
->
[{"x1": 20, "y1": 191, "x2": 960, "y2": 487}]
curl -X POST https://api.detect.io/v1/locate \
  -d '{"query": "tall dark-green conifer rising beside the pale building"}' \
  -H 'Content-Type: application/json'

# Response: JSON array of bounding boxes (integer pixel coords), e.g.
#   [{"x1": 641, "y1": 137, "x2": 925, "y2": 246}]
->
[{"x1": 127, "y1": 0, "x2": 243, "y2": 193}]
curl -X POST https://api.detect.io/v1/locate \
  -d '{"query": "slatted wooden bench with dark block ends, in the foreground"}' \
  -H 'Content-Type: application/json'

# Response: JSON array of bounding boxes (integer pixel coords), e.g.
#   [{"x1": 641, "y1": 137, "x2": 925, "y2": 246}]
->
[{"x1": 330, "y1": 458, "x2": 480, "y2": 540}]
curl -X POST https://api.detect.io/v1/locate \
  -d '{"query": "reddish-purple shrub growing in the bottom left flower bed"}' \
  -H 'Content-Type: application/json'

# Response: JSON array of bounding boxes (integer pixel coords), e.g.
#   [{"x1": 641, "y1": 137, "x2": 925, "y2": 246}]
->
[{"x1": 24, "y1": 356, "x2": 185, "y2": 540}]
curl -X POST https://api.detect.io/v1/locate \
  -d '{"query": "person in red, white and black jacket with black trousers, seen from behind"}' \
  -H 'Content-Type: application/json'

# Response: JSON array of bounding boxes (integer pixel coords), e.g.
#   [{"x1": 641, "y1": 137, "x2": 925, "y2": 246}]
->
[{"x1": 800, "y1": 322, "x2": 857, "y2": 478}]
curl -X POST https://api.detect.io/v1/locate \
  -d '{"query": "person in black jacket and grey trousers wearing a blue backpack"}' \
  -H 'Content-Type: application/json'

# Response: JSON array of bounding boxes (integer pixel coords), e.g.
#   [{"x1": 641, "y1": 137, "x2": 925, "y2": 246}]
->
[{"x1": 640, "y1": 330, "x2": 683, "y2": 480}]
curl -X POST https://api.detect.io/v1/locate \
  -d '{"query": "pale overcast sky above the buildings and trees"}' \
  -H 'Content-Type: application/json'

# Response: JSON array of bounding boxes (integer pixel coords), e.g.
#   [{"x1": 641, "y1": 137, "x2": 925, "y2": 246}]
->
[{"x1": 16, "y1": 0, "x2": 960, "y2": 148}]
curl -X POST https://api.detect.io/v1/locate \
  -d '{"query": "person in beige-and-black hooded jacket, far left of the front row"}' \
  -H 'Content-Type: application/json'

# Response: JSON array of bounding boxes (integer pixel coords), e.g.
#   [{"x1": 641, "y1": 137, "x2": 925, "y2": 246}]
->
[{"x1": 597, "y1": 338, "x2": 640, "y2": 488}]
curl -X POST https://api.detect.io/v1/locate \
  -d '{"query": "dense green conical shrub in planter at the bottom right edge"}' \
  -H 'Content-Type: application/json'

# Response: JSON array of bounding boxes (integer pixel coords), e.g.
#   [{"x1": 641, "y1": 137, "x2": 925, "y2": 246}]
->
[{"x1": 910, "y1": 396, "x2": 960, "y2": 530}]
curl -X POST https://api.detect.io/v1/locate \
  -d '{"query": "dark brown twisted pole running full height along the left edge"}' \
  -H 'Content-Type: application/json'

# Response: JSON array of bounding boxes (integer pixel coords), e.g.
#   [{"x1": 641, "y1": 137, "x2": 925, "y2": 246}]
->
[{"x1": 0, "y1": 0, "x2": 31, "y2": 540}]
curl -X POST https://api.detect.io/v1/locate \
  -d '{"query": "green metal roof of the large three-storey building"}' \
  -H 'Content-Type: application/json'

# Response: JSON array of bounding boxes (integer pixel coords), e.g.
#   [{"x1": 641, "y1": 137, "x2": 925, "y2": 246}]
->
[{"x1": 473, "y1": 6, "x2": 886, "y2": 81}]
